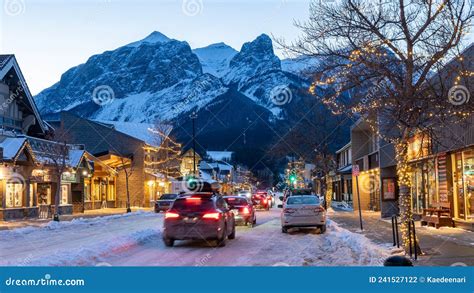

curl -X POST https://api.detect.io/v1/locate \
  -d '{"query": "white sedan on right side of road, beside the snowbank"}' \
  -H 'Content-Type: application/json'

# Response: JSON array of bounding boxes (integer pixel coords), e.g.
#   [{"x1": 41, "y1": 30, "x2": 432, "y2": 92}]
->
[{"x1": 281, "y1": 195, "x2": 326, "y2": 233}]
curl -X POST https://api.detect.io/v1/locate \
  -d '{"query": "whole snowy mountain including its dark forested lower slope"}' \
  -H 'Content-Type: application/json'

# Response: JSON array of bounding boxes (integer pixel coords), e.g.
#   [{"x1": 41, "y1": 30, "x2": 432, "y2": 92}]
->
[{"x1": 35, "y1": 32, "x2": 348, "y2": 155}]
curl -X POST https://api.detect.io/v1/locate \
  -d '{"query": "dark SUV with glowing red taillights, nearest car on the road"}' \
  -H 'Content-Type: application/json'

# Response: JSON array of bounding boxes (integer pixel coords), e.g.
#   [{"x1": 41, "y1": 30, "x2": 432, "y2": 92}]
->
[{"x1": 163, "y1": 193, "x2": 235, "y2": 246}]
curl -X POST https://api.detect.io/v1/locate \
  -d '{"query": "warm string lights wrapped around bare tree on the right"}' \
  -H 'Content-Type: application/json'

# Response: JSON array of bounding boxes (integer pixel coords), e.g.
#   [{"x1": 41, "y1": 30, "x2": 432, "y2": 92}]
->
[{"x1": 309, "y1": 38, "x2": 474, "y2": 252}]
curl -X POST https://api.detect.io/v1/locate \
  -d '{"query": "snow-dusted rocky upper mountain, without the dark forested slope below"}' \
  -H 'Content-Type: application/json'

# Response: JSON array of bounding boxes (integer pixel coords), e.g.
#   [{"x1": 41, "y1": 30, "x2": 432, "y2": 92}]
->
[{"x1": 35, "y1": 32, "x2": 307, "y2": 123}]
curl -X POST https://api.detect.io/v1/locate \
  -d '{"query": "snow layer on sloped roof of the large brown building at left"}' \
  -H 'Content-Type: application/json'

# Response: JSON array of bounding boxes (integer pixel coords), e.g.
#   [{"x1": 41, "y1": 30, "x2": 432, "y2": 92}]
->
[{"x1": 96, "y1": 120, "x2": 171, "y2": 147}]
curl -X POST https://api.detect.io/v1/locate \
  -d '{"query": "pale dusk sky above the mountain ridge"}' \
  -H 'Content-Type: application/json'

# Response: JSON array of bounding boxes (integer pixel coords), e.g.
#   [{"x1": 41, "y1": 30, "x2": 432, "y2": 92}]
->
[{"x1": 0, "y1": 0, "x2": 472, "y2": 94}]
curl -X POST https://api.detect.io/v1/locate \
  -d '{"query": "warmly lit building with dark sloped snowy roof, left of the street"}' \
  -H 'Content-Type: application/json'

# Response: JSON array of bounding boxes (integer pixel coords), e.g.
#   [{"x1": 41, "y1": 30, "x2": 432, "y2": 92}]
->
[{"x1": 60, "y1": 112, "x2": 171, "y2": 208}]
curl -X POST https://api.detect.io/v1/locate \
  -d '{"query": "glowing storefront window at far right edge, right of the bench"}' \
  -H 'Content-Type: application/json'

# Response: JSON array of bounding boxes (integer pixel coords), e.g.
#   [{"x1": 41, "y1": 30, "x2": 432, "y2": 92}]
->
[{"x1": 453, "y1": 150, "x2": 474, "y2": 221}]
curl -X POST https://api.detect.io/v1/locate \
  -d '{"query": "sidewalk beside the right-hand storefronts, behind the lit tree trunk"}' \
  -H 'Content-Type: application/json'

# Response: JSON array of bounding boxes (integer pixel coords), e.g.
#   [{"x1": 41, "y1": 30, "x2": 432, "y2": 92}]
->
[{"x1": 328, "y1": 210, "x2": 474, "y2": 266}]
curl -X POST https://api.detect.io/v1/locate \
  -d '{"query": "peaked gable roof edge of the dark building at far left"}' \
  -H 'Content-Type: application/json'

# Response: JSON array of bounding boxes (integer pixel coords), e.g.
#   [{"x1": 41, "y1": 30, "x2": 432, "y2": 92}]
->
[{"x1": 0, "y1": 55, "x2": 46, "y2": 133}]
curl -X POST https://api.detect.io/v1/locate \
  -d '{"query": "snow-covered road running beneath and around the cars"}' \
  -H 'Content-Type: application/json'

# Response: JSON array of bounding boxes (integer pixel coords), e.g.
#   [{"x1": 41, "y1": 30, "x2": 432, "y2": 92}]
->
[{"x1": 0, "y1": 208, "x2": 390, "y2": 266}]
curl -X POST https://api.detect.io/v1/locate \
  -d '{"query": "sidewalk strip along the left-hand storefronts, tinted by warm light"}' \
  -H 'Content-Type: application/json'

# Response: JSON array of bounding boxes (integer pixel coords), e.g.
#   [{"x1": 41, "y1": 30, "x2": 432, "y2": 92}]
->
[{"x1": 0, "y1": 208, "x2": 152, "y2": 230}]
